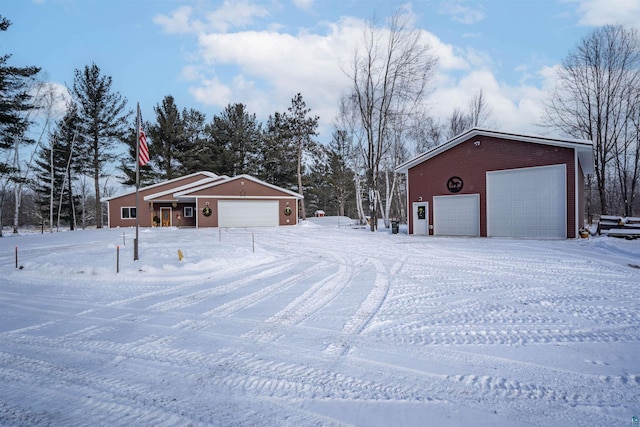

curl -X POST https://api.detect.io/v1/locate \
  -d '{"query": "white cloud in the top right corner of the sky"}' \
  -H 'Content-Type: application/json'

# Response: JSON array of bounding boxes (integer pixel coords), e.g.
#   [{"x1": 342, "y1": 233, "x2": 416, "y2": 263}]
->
[{"x1": 565, "y1": 0, "x2": 640, "y2": 28}]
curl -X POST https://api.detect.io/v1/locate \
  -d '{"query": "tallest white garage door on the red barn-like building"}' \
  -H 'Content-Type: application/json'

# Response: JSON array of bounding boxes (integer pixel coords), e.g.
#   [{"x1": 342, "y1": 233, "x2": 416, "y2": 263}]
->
[{"x1": 487, "y1": 165, "x2": 567, "y2": 238}]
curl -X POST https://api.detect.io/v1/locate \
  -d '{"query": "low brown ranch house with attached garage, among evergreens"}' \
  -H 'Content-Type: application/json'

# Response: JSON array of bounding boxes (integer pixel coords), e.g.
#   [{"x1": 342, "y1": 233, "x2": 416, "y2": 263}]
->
[{"x1": 102, "y1": 172, "x2": 302, "y2": 228}]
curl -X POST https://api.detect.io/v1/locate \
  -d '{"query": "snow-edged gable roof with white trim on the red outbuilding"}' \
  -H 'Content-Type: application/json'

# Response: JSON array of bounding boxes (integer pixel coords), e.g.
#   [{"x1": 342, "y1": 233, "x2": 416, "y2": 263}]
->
[{"x1": 396, "y1": 128, "x2": 594, "y2": 174}]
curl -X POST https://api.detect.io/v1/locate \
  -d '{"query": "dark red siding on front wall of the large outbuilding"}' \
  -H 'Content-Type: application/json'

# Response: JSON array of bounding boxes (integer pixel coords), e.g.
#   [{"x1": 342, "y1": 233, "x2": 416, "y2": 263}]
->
[{"x1": 408, "y1": 136, "x2": 576, "y2": 238}]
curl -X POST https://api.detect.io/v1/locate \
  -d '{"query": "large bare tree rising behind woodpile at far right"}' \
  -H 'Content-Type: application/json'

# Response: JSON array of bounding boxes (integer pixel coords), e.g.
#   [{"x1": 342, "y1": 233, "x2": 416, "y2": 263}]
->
[{"x1": 545, "y1": 25, "x2": 640, "y2": 214}]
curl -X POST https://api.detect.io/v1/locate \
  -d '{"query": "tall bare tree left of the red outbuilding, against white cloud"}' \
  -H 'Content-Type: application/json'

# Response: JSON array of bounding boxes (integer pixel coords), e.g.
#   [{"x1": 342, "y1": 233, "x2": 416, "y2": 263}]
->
[{"x1": 349, "y1": 10, "x2": 437, "y2": 231}]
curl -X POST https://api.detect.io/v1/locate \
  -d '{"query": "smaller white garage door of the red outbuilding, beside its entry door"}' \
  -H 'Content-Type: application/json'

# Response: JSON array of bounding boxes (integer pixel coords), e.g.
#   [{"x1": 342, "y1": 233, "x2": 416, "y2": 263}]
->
[{"x1": 433, "y1": 194, "x2": 480, "y2": 236}]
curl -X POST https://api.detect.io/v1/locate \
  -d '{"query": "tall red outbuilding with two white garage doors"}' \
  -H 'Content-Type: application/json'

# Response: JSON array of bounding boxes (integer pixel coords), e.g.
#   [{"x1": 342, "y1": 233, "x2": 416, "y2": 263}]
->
[{"x1": 396, "y1": 128, "x2": 594, "y2": 239}]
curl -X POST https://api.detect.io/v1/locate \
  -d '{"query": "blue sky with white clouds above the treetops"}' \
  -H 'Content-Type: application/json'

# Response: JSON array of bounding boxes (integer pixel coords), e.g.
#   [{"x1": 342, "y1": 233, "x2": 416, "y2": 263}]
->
[{"x1": 0, "y1": 0, "x2": 640, "y2": 142}]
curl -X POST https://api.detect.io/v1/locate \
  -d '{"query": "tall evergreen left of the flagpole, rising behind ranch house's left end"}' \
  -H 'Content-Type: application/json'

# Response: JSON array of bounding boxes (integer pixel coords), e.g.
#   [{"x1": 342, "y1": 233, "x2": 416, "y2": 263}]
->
[{"x1": 72, "y1": 63, "x2": 131, "y2": 228}]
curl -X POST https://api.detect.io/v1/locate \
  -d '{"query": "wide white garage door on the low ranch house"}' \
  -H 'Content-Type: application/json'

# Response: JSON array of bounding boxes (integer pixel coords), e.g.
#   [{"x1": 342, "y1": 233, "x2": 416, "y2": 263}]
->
[{"x1": 218, "y1": 200, "x2": 280, "y2": 228}]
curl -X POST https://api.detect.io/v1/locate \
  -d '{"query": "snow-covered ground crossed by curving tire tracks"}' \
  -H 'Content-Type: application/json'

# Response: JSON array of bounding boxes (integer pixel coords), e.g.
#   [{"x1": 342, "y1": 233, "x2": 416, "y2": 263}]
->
[{"x1": 0, "y1": 218, "x2": 640, "y2": 427}]
